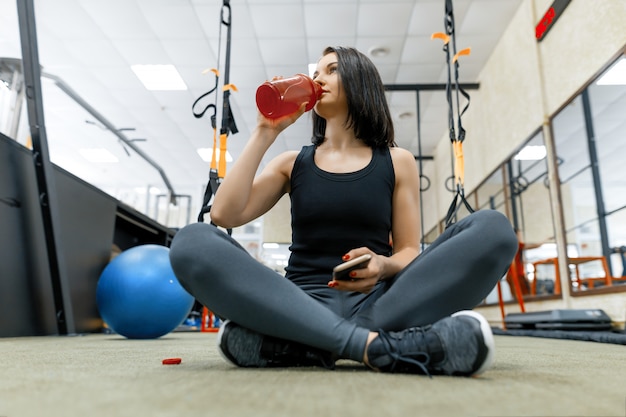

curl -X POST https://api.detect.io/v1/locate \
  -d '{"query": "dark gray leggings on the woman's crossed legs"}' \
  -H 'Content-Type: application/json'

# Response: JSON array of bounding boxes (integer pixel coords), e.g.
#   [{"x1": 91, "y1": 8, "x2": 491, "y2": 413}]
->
[{"x1": 170, "y1": 210, "x2": 517, "y2": 361}]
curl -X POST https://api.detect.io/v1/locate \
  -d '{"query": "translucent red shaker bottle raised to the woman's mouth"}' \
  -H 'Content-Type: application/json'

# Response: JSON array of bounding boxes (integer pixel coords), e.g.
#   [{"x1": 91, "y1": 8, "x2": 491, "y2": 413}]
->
[{"x1": 256, "y1": 74, "x2": 322, "y2": 119}]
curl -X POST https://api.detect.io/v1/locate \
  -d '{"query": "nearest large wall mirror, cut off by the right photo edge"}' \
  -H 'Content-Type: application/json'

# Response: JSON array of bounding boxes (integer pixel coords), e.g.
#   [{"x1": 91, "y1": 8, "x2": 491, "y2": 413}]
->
[{"x1": 552, "y1": 57, "x2": 626, "y2": 293}]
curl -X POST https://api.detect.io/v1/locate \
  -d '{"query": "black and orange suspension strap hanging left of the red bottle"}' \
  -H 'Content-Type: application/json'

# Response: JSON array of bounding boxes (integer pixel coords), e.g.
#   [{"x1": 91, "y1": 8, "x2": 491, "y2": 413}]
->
[{"x1": 191, "y1": 0, "x2": 238, "y2": 226}]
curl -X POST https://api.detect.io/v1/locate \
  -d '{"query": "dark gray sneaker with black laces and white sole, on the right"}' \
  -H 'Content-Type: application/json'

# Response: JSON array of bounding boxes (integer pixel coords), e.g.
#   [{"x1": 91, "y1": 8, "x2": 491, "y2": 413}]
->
[{"x1": 367, "y1": 311, "x2": 495, "y2": 376}]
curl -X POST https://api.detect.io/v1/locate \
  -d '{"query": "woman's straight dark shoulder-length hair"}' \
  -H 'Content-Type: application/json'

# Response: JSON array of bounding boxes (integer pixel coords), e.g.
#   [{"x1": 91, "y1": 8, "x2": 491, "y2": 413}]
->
[{"x1": 311, "y1": 46, "x2": 396, "y2": 148}]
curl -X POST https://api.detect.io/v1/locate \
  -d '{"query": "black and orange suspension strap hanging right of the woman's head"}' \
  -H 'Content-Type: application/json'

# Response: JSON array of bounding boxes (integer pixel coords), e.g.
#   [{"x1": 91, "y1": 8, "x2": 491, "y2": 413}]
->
[{"x1": 431, "y1": 0, "x2": 474, "y2": 228}]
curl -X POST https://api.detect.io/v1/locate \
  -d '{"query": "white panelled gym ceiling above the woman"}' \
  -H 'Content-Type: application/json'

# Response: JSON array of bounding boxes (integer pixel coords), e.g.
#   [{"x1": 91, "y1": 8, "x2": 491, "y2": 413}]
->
[{"x1": 0, "y1": 0, "x2": 520, "y2": 204}]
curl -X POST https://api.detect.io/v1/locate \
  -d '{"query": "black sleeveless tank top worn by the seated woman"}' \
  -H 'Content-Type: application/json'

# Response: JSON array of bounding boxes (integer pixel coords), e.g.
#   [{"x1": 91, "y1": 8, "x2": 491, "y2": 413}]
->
[{"x1": 286, "y1": 145, "x2": 395, "y2": 285}]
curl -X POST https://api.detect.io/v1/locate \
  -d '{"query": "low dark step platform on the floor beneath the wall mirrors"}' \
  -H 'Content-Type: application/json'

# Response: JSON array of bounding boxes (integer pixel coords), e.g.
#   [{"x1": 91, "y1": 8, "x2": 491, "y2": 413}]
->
[{"x1": 504, "y1": 309, "x2": 612, "y2": 330}]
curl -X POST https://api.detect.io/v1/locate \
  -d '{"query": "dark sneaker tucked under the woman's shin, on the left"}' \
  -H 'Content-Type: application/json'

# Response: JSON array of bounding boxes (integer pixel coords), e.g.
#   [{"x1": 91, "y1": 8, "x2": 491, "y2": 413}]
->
[{"x1": 217, "y1": 320, "x2": 335, "y2": 369}]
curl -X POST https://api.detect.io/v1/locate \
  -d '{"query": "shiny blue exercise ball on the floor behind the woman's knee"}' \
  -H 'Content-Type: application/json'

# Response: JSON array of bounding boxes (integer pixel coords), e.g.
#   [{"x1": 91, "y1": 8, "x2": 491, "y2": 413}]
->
[{"x1": 96, "y1": 245, "x2": 194, "y2": 339}]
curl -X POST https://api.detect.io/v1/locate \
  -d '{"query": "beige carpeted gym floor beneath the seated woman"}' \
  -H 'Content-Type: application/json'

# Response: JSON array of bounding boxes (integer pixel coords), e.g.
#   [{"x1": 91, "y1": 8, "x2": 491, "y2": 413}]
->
[{"x1": 0, "y1": 332, "x2": 626, "y2": 417}]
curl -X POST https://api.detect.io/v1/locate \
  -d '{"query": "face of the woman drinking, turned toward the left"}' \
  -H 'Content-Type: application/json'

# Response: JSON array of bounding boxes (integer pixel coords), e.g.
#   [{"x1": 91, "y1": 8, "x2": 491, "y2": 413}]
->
[{"x1": 313, "y1": 52, "x2": 348, "y2": 119}]
